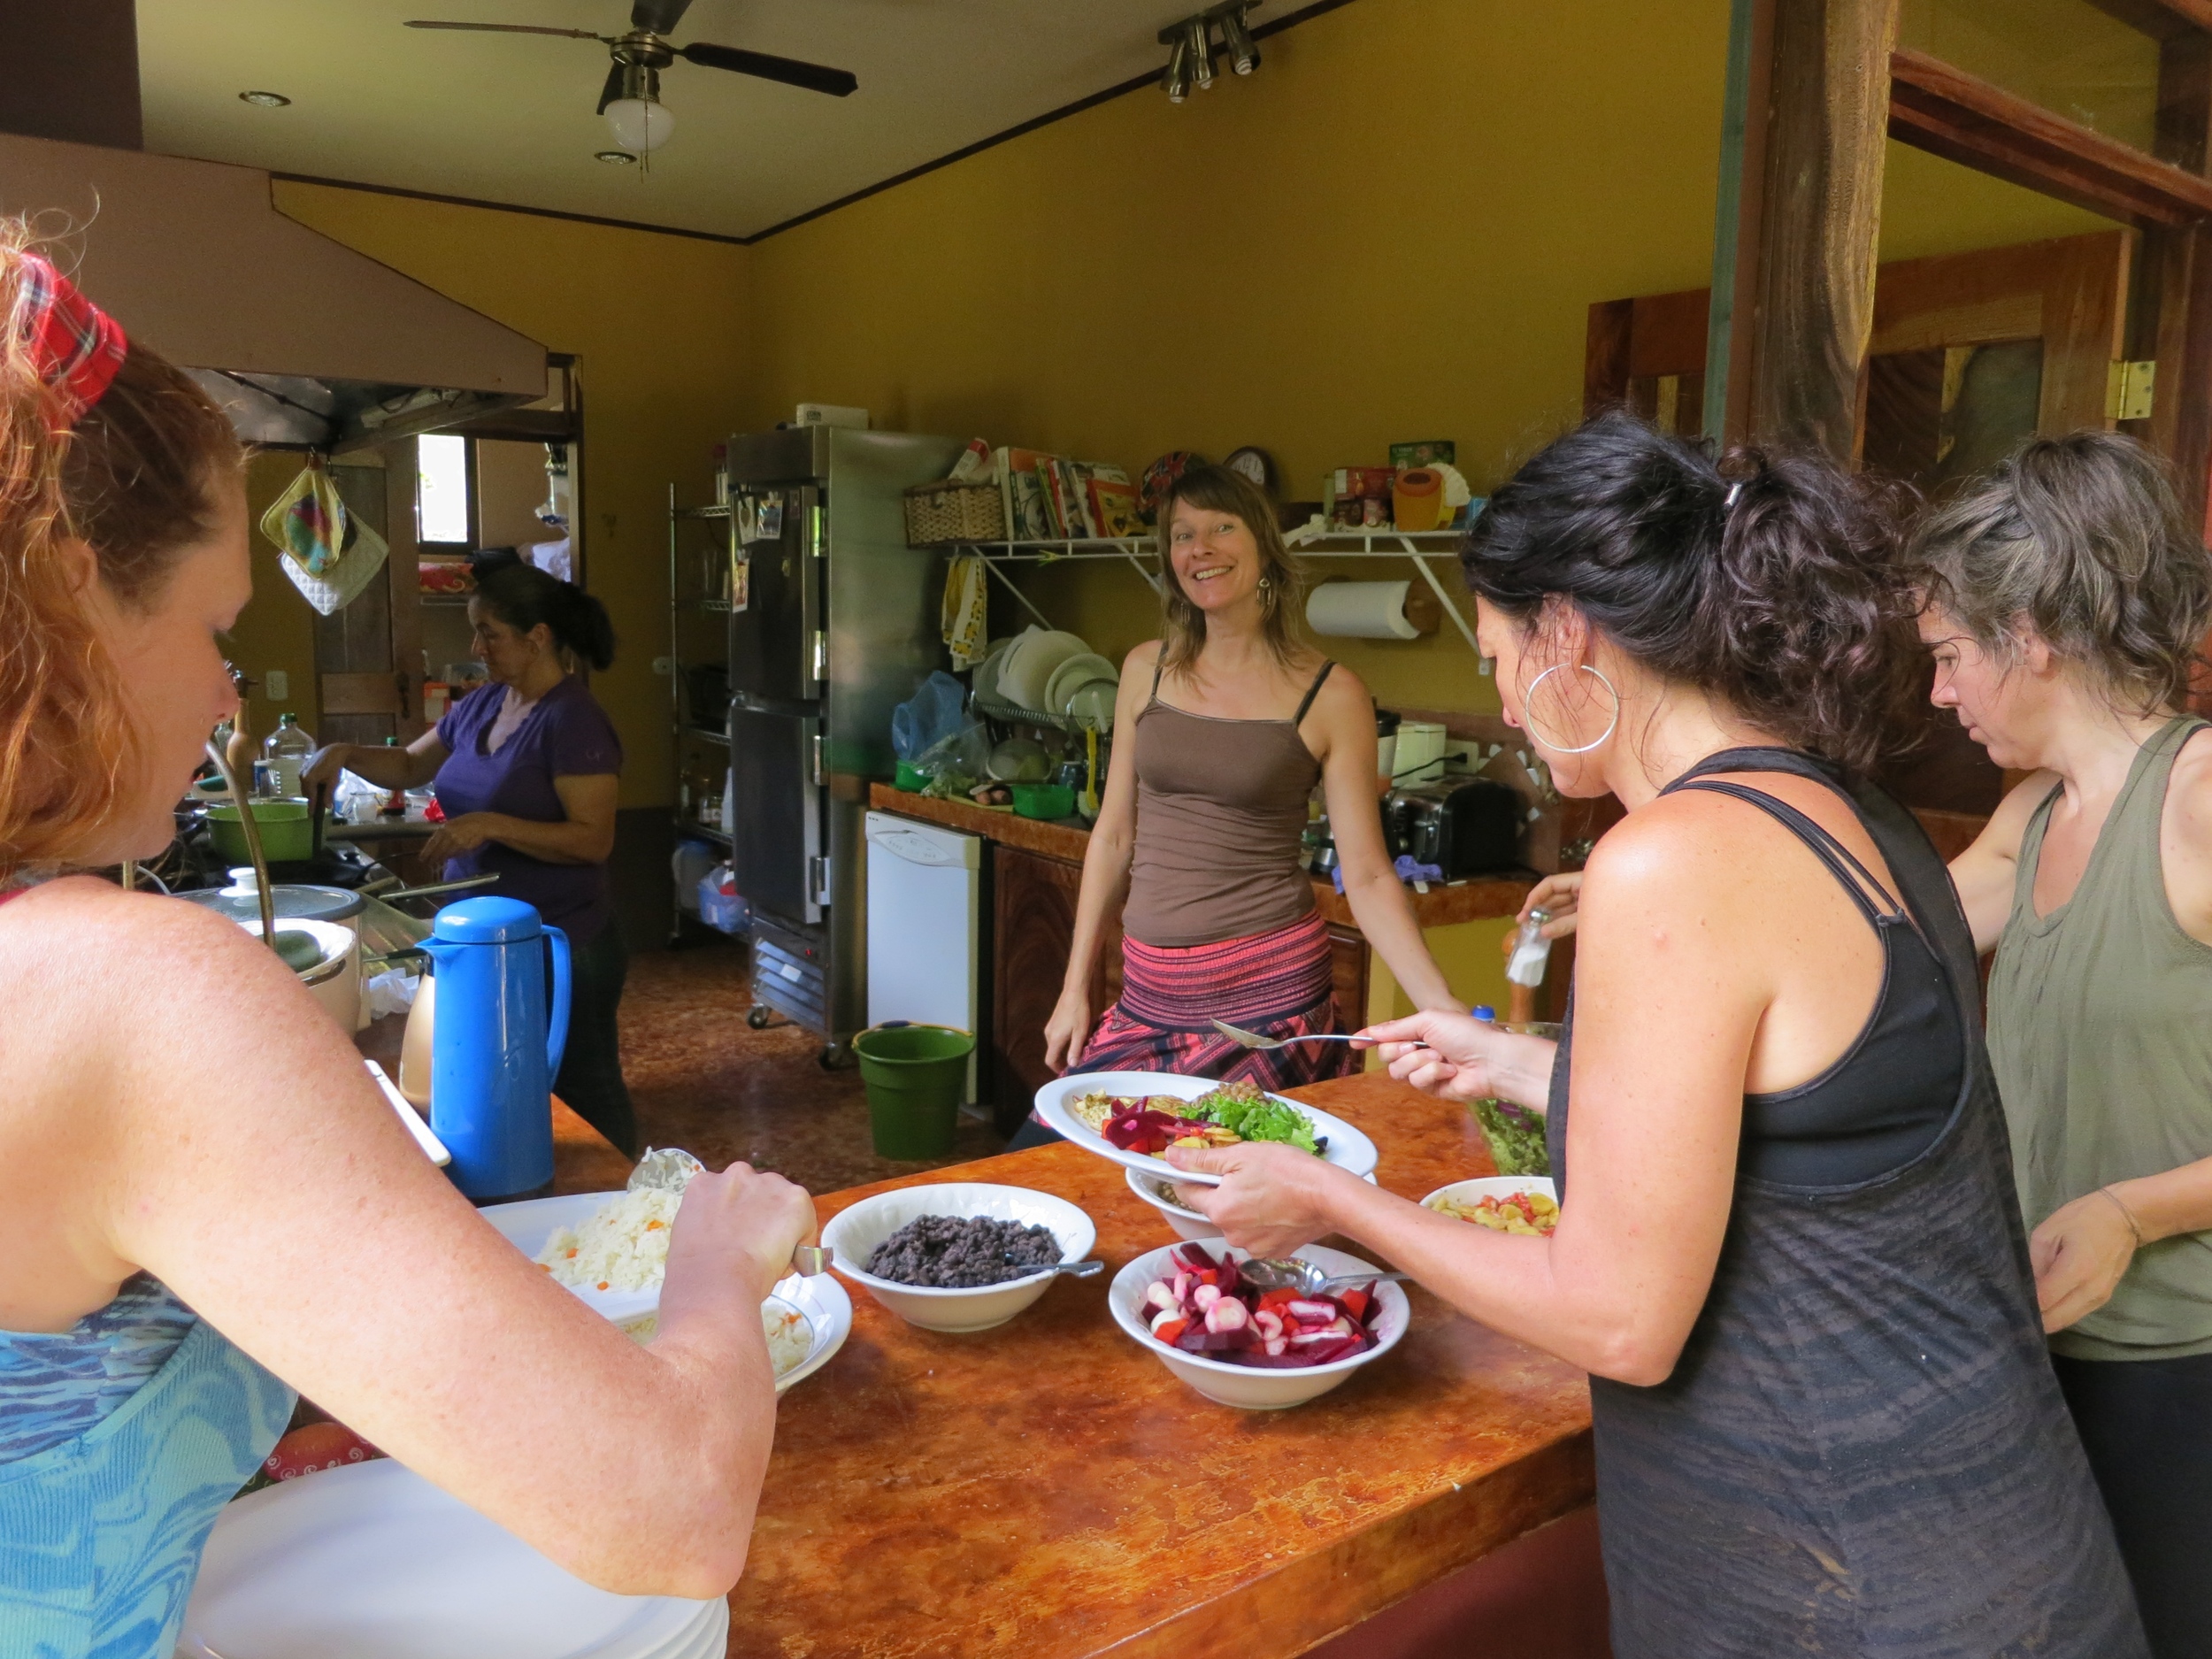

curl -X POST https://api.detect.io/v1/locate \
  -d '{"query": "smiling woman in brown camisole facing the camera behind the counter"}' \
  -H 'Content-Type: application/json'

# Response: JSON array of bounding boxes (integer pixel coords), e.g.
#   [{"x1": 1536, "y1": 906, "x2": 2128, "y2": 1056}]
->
[{"x1": 1026, "y1": 467, "x2": 1455, "y2": 1110}]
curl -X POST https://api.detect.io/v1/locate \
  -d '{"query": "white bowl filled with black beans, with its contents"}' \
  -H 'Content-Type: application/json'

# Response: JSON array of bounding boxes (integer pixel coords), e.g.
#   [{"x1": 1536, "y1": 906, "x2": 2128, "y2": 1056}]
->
[{"x1": 823, "y1": 1181, "x2": 1097, "y2": 1332}]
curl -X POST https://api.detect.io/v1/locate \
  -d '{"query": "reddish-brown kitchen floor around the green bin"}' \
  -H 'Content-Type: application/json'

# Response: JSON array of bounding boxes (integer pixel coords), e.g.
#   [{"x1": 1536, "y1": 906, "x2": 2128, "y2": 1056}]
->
[{"x1": 622, "y1": 933, "x2": 1002, "y2": 1193}]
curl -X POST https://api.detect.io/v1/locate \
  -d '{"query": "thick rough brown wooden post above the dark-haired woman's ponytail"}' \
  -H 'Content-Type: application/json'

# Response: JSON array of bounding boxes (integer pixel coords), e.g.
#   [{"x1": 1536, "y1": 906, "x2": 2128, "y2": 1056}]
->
[{"x1": 1706, "y1": 0, "x2": 1898, "y2": 463}]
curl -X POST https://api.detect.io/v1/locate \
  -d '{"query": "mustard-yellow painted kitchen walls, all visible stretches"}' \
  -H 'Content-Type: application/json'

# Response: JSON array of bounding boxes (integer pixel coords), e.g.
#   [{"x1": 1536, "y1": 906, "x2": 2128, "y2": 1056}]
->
[{"x1": 258, "y1": 0, "x2": 2141, "y2": 805}]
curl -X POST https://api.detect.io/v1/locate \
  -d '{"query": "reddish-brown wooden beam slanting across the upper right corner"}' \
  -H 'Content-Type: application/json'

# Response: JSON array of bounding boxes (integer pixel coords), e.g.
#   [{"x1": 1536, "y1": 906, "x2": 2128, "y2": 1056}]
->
[{"x1": 1889, "y1": 47, "x2": 2212, "y2": 228}]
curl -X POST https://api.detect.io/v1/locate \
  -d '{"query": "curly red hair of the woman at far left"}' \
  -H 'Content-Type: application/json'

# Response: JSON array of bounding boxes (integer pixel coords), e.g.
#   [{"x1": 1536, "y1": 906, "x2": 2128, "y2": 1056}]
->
[{"x1": 0, "y1": 235, "x2": 243, "y2": 883}]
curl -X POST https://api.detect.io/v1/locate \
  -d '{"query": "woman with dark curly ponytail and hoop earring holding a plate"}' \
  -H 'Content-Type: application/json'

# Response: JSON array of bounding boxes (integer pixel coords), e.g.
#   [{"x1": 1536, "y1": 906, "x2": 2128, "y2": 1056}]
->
[{"x1": 1171, "y1": 416, "x2": 2144, "y2": 1659}]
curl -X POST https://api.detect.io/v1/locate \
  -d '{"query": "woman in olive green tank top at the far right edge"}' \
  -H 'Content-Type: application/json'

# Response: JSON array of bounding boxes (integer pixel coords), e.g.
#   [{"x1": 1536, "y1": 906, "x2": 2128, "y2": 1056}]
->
[{"x1": 1916, "y1": 432, "x2": 2212, "y2": 1659}]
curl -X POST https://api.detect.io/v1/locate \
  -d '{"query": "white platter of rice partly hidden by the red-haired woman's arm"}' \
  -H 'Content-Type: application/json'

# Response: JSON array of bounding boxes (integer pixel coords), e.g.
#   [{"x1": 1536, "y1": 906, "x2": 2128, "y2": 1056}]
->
[{"x1": 480, "y1": 1188, "x2": 852, "y2": 1394}]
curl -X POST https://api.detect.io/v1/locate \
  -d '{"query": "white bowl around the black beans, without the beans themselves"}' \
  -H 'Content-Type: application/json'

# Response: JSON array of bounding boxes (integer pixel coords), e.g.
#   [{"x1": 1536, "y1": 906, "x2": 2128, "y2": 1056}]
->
[{"x1": 823, "y1": 1181, "x2": 1100, "y2": 1332}]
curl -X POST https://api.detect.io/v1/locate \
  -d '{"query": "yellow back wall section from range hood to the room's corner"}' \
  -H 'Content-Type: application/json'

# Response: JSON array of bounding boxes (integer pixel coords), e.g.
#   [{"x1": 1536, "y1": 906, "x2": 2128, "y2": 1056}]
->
[{"x1": 264, "y1": 184, "x2": 750, "y2": 805}]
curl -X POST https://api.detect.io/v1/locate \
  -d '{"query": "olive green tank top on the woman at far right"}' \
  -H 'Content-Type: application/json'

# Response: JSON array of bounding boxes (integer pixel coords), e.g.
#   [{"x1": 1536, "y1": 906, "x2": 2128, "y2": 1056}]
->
[{"x1": 1989, "y1": 715, "x2": 2212, "y2": 1361}]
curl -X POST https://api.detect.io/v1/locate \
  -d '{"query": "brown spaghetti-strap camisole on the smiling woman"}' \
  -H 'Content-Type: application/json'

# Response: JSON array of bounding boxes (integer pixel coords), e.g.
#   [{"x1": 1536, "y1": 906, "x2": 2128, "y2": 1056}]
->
[{"x1": 1122, "y1": 662, "x2": 1336, "y2": 947}]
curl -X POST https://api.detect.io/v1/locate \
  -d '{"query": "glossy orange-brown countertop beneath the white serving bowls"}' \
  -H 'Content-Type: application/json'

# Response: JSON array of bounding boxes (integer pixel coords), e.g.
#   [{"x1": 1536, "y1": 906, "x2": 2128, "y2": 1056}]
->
[{"x1": 556, "y1": 1075, "x2": 1595, "y2": 1659}]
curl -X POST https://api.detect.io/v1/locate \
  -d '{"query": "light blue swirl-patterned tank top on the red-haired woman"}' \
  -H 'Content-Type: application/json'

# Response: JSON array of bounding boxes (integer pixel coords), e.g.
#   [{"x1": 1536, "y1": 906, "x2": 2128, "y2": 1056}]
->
[{"x1": 0, "y1": 1274, "x2": 296, "y2": 1659}]
